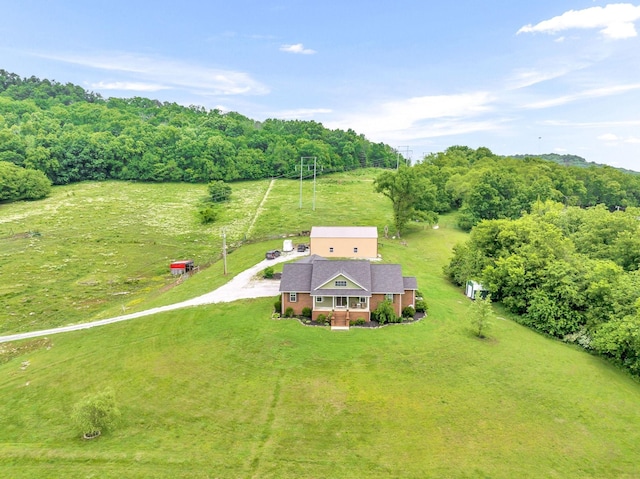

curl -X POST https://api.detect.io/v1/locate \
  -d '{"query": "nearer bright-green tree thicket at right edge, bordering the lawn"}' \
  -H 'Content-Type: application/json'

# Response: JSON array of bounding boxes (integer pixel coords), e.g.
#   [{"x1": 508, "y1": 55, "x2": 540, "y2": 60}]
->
[{"x1": 446, "y1": 201, "x2": 640, "y2": 374}]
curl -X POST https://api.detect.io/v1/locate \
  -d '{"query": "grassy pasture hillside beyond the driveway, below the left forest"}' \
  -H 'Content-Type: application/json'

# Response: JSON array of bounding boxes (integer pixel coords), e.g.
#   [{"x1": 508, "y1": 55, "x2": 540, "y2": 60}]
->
[{"x1": 0, "y1": 170, "x2": 391, "y2": 333}]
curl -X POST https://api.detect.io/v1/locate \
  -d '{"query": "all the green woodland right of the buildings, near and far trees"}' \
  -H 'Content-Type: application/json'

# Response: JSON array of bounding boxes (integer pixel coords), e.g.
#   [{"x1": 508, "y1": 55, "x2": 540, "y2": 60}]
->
[{"x1": 384, "y1": 147, "x2": 640, "y2": 375}]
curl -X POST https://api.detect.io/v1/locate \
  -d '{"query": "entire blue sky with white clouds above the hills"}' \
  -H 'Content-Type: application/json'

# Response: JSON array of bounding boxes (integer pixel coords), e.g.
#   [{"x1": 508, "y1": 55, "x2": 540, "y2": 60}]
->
[{"x1": 0, "y1": 0, "x2": 640, "y2": 171}]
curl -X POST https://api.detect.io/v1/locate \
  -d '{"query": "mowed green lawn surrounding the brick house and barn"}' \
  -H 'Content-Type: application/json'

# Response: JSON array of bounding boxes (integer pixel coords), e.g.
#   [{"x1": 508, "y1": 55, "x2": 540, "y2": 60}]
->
[{"x1": 0, "y1": 172, "x2": 640, "y2": 478}]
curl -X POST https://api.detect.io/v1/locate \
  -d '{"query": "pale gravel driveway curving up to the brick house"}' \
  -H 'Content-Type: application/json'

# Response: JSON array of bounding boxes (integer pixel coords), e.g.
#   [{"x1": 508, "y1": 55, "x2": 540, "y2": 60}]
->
[{"x1": 0, "y1": 251, "x2": 309, "y2": 343}]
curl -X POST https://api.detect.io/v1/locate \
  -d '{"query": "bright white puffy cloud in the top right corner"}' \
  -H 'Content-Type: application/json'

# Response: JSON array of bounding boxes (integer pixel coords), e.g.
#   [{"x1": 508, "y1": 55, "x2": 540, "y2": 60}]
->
[{"x1": 517, "y1": 3, "x2": 640, "y2": 40}]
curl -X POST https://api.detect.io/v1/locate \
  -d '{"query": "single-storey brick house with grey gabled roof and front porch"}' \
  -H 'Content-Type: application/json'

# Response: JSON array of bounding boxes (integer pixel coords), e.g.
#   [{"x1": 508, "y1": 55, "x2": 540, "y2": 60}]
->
[{"x1": 280, "y1": 255, "x2": 418, "y2": 328}]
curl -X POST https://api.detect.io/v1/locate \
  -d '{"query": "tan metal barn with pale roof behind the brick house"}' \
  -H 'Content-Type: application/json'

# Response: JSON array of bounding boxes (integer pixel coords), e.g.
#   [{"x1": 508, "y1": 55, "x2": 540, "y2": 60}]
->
[{"x1": 310, "y1": 226, "x2": 378, "y2": 258}]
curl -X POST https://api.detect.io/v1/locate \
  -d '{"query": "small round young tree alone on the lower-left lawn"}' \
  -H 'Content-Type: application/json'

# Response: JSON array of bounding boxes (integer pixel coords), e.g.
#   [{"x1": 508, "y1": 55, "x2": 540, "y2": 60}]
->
[{"x1": 72, "y1": 388, "x2": 120, "y2": 437}]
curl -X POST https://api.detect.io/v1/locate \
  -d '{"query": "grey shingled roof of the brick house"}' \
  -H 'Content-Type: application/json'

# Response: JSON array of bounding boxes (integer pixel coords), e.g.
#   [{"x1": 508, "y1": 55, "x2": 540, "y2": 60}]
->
[{"x1": 280, "y1": 256, "x2": 417, "y2": 297}]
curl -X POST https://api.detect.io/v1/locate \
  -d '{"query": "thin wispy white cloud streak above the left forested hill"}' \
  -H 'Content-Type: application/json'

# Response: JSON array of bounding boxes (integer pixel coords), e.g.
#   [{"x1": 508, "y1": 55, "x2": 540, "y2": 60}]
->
[{"x1": 38, "y1": 53, "x2": 269, "y2": 95}]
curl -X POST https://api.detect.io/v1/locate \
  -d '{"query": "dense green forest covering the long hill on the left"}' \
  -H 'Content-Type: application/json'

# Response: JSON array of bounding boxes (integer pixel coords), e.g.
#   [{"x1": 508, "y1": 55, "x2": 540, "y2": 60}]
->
[{"x1": 0, "y1": 70, "x2": 396, "y2": 193}]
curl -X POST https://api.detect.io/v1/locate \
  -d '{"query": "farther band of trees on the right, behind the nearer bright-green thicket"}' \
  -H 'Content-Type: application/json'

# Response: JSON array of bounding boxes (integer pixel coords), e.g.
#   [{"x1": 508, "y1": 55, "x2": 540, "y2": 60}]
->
[{"x1": 415, "y1": 146, "x2": 640, "y2": 230}]
